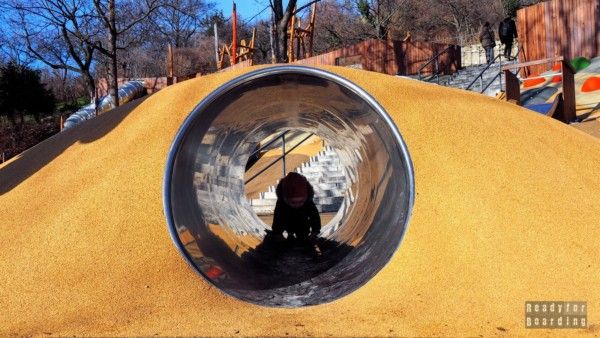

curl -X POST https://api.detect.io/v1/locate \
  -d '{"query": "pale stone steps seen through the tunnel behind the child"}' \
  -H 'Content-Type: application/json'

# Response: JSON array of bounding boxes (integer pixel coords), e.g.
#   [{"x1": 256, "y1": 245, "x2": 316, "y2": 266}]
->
[{"x1": 250, "y1": 147, "x2": 354, "y2": 215}]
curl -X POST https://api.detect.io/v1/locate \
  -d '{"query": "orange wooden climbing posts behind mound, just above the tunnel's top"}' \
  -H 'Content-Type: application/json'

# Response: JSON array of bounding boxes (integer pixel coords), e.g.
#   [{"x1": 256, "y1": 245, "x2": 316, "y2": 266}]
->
[{"x1": 288, "y1": 3, "x2": 317, "y2": 62}]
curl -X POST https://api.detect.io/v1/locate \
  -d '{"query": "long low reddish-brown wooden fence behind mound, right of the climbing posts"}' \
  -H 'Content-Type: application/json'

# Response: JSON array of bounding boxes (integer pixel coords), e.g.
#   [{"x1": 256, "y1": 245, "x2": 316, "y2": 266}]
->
[{"x1": 294, "y1": 39, "x2": 461, "y2": 75}]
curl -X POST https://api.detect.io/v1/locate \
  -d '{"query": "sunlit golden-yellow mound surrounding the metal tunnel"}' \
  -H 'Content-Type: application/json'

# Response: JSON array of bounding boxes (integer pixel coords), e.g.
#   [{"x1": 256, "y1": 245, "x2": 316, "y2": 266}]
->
[{"x1": 0, "y1": 68, "x2": 600, "y2": 336}]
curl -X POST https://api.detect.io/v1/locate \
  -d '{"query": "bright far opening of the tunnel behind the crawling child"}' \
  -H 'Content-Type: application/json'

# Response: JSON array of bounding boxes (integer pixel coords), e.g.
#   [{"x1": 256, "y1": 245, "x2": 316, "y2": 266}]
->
[{"x1": 244, "y1": 130, "x2": 353, "y2": 236}]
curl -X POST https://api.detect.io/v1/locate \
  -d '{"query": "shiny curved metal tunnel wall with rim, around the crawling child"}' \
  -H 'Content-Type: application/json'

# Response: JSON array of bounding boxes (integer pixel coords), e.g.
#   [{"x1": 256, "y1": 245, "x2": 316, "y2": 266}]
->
[{"x1": 163, "y1": 66, "x2": 414, "y2": 307}]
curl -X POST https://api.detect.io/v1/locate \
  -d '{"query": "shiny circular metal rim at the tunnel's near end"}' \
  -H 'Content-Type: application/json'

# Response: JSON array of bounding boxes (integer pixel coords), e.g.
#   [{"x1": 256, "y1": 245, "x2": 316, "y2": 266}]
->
[{"x1": 162, "y1": 65, "x2": 416, "y2": 308}]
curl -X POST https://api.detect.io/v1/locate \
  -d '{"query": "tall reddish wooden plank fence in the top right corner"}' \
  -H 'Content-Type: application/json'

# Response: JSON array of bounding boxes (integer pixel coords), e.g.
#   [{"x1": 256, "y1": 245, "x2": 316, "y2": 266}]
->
[{"x1": 517, "y1": 0, "x2": 600, "y2": 73}]
